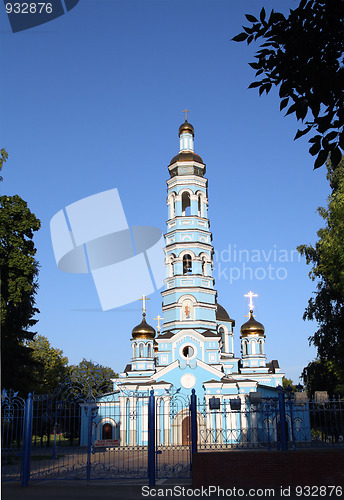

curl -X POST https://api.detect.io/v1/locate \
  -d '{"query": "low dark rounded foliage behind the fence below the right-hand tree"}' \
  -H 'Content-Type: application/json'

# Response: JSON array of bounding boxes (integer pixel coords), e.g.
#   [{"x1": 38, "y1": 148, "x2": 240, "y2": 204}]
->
[{"x1": 301, "y1": 359, "x2": 344, "y2": 398}]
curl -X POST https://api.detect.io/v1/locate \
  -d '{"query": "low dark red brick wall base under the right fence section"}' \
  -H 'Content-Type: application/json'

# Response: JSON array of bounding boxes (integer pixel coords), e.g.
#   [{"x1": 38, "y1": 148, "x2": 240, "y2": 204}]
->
[{"x1": 192, "y1": 449, "x2": 344, "y2": 488}]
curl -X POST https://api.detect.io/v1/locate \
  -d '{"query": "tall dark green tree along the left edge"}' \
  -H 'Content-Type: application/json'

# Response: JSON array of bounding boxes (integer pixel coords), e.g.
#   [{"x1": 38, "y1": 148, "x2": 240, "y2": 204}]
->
[{"x1": 0, "y1": 195, "x2": 41, "y2": 392}]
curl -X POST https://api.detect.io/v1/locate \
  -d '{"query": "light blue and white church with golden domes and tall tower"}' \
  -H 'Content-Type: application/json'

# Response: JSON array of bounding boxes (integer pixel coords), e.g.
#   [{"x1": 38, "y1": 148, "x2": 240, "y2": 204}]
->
[{"x1": 81, "y1": 118, "x2": 292, "y2": 446}]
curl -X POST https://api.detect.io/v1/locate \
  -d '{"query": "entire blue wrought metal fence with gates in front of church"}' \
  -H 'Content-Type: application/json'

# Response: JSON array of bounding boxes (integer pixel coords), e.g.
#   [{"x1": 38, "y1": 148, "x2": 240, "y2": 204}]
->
[{"x1": 1, "y1": 383, "x2": 344, "y2": 485}]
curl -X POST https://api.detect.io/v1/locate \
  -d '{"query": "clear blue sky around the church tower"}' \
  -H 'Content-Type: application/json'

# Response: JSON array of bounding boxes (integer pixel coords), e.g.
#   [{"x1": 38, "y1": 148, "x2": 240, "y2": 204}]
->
[{"x1": 0, "y1": 0, "x2": 329, "y2": 383}]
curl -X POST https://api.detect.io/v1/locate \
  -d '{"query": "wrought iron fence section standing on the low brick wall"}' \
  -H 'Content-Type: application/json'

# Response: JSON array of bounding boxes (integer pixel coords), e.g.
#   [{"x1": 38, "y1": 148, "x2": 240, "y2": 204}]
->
[{"x1": 197, "y1": 392, "x2": 344, "y2": 451}]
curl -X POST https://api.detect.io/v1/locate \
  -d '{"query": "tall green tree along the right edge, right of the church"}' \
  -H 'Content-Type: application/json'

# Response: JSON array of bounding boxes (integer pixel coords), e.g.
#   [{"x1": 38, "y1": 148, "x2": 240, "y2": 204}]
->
[{"x1": 298, "y1": 158, "x2": 344, "y2": 385}]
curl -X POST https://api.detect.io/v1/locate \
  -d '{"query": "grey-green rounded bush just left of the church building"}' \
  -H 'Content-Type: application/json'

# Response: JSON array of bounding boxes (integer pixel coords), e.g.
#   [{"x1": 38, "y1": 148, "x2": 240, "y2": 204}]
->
[{"x1": 69, "y1": 358, "x2": 118, "y2": 396}]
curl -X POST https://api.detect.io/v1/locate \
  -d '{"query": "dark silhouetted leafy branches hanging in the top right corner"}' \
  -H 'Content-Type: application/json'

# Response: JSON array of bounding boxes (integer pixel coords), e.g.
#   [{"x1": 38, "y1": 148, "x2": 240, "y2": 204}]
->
[{"x1": 233, "y1": 0, "x2": 344, "y2": 169}]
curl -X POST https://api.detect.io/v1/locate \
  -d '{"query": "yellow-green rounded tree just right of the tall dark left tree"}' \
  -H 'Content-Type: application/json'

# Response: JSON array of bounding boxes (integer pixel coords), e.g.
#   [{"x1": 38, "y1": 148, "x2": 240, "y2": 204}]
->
[{"x1": 27, "y1": 335, "x2": 68, "y2": 394}]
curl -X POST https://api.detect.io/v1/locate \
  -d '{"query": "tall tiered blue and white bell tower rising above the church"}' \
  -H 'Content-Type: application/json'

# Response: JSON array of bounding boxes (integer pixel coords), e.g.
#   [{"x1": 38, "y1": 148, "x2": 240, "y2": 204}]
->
[{"x1": 162, "y1": 118, "x2": 217, "y2": 334}]
